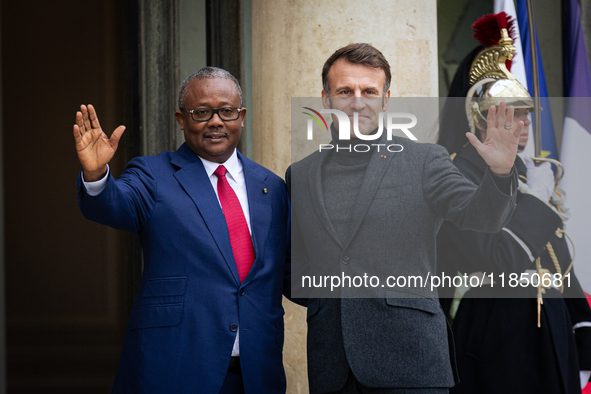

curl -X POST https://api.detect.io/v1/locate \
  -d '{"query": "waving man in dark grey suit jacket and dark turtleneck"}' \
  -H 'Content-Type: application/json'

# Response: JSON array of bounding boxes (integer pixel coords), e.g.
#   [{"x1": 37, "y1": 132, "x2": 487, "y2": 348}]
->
[{"x1": 286, "y1": 44, "x2": 523, "y2": 393}]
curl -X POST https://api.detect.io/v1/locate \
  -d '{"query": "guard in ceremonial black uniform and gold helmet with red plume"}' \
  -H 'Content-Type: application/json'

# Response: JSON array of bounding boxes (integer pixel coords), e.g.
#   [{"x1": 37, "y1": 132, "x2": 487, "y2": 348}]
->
[{"x1": 437, "y1": 13, "x2": 591, "y2": 394}]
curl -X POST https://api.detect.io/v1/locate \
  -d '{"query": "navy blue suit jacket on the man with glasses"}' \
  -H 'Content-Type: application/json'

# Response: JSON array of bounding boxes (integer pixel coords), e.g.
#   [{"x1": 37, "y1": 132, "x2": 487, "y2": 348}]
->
[{"x1": 78, "y1": 144, "x2": 290, "y2": 394}]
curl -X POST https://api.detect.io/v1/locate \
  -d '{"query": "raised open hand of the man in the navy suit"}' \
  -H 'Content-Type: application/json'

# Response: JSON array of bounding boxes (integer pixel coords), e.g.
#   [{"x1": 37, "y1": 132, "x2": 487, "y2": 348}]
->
[{"x1": 74, "y1": 104, "x2": 125, "y2": 182}]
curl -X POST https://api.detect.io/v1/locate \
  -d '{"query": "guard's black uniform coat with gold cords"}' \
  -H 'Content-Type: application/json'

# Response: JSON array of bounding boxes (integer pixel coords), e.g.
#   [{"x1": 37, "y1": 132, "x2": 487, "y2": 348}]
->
[{"x1": 437, "y1": 145, "x2": 591, "y2": 393}]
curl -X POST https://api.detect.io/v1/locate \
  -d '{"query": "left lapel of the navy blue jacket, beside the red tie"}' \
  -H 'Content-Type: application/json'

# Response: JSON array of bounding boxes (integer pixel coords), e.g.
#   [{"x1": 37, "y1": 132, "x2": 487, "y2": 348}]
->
[{"x1": 171, "y1": 144, "x2": 242, "y2": 285}]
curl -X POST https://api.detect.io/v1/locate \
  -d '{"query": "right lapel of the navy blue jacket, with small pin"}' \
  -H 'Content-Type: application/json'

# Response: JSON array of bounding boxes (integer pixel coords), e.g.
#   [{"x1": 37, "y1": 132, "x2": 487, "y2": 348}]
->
[{"x1": 238, "y1": 152, "x2": 270, "y2": 285}]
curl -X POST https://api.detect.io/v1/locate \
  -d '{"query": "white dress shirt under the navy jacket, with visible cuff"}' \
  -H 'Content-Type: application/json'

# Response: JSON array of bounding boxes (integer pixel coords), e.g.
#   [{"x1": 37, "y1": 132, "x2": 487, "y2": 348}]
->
[{"x1": 82, "y1": 149, "x2": 252, "y2": 356}]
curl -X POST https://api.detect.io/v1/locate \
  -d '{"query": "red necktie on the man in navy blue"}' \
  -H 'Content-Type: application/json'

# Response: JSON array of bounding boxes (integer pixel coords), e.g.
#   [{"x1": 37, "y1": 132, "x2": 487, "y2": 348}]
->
[{"x1": 214, "y1": 165, "x2": 255, "y2": 282}]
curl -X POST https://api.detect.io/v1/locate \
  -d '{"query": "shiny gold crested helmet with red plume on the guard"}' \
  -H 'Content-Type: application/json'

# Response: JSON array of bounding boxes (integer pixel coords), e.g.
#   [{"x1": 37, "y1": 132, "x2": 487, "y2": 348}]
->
[{"x1": 465, "y1": 12, "x2": 534, "y2": 133}]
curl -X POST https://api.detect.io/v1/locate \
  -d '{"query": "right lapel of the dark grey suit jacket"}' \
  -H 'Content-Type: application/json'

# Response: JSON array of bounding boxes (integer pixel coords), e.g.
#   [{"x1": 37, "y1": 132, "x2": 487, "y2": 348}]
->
[{"x1": 344, "y1": 141, "x2": 396, "y2": 249}]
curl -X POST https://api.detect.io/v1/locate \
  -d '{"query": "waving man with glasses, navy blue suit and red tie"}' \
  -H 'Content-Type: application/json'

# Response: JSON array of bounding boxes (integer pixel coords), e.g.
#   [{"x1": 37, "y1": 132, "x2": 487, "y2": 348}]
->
[{"x1": 74, "y1": 67, "x2": 290, "y2": 393}]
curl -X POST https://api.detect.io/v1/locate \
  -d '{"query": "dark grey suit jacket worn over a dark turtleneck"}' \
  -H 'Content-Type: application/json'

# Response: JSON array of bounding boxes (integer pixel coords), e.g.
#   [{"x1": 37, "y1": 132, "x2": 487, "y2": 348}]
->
[{"x1": 286, "y1": 137, "x2": 517, "y2": 393}]
